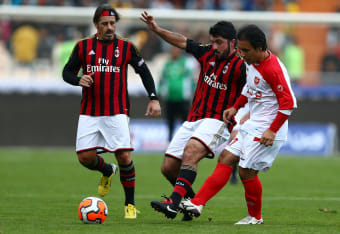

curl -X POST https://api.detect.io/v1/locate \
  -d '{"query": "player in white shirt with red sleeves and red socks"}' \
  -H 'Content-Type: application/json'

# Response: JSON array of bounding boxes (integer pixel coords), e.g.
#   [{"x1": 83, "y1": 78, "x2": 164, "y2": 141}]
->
[{"x1": 182, "y1": 25, "x2": 297, "y2": 224}]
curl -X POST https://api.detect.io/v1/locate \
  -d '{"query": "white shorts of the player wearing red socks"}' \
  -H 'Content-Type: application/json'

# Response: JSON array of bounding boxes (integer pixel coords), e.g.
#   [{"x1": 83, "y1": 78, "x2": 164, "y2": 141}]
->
[{"x1": 225, "y1": 130, "x2": 285, "y2": 171}]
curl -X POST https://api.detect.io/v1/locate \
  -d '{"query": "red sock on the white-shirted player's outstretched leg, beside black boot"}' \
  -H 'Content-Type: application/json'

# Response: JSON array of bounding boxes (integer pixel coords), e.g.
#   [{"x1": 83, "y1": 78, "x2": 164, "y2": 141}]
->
[{"x1": 191, "y1": 163, "x2": 233, "y2": 205}]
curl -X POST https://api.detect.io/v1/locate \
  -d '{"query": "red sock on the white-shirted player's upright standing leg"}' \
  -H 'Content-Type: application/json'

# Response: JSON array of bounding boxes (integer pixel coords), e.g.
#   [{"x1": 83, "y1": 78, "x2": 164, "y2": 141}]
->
[{"x1": 242, "y1": 176, "x2": 262, "y2": 219}]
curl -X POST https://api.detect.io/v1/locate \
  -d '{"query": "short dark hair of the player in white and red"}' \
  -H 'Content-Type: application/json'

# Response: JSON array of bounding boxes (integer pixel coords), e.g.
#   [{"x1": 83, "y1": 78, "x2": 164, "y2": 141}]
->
[{"x1": 237, "y1": 24, "x2": 267, "y2": 50}]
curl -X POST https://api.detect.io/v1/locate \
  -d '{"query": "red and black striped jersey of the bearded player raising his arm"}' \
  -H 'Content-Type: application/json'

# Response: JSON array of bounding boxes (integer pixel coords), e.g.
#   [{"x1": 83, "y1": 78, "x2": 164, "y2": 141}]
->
[{"x1": 186, "y1": 39, "x2": 246, "y2": 121}]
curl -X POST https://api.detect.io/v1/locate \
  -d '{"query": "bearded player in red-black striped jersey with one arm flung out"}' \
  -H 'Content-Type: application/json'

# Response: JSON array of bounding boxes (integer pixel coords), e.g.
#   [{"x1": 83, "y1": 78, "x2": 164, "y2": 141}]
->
[{"x1": 141, "y1": 12, "x2": 246, "y2": 219}]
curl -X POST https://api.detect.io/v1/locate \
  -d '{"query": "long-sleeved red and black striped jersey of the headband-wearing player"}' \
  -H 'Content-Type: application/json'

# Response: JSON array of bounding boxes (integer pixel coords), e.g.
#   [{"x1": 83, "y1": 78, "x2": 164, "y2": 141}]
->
[{"x1": 63, "y1": 35, "x2": 155, "y2": 116}]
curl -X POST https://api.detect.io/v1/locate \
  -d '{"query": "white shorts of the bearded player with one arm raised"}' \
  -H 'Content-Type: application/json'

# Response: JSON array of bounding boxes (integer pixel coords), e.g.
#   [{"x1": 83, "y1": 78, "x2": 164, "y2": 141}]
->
[{"x1": 165, "y1": 118, "x2": 230, "y2": 159}]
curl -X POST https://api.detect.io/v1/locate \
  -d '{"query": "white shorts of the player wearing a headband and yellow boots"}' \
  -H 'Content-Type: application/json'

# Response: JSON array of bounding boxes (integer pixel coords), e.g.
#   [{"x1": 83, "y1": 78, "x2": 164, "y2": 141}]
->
[{"x1": 76, "y1": 114, "x2": 133, "y2": 152}]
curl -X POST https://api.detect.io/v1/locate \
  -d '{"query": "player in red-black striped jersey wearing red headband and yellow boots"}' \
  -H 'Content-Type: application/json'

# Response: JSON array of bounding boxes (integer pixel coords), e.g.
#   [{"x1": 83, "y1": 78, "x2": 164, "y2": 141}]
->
[{"x1": 63, "y1": 4, "x2": 161, "y2": 219}]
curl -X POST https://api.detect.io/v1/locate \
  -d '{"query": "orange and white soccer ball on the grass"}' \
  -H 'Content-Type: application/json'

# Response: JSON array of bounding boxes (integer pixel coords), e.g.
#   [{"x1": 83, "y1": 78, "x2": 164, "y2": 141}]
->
[{"x1": 78, "y1": 197, "x2": 108, "y2": 224}]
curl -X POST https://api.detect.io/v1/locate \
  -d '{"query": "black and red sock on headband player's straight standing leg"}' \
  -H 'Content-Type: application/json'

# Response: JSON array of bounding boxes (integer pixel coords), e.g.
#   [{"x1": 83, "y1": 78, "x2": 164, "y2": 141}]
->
[{"x1": 119, "y1": 161, "x2": 135, "y2": 206}]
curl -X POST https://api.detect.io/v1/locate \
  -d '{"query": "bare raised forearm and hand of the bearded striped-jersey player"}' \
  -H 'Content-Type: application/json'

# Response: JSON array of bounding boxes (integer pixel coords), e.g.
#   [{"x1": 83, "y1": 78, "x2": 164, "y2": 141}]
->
[{"x1": 140, "y1": 11, "x2": 187, "y2": 49}]
